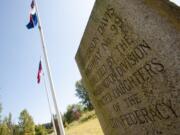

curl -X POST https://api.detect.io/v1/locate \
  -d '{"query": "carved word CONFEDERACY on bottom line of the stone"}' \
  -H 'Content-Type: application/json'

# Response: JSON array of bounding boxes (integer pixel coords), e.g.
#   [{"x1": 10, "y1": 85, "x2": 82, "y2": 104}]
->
[{"x1": 110, "y1": 100, "x2": 178, "y2": 129}]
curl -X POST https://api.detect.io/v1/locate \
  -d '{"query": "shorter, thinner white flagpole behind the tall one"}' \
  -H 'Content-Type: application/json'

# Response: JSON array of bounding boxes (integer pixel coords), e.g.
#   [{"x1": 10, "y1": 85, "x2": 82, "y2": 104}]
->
[{"x1": 43, "y1": 73, "x2": 57, "y2": 135}]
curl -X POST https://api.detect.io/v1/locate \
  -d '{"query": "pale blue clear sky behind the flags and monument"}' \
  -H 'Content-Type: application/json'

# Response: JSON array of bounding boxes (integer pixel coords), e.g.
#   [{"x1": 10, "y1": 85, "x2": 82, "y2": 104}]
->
[{"x1": 0, "y1": 0, "x2": 180, "y2": 124}]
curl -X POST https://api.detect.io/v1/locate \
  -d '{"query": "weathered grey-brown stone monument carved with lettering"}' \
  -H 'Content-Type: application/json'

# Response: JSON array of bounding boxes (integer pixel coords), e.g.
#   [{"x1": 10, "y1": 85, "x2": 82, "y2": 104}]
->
[{"x1": 76, "y1": 0, "x2": 180, "y2": 135}]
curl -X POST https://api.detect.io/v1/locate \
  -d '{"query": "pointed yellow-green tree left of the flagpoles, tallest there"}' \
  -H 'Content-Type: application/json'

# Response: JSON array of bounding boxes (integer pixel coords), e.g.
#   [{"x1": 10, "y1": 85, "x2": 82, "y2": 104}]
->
[{"x1": 19, "y1": 110, "x2": 35, "y2": 135}]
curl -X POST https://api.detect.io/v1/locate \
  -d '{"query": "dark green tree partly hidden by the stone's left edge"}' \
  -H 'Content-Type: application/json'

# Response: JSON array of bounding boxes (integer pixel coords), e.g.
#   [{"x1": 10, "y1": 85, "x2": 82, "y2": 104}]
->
[{"x1": 76, "y1": 80, "x2": 93, "y2": 110}]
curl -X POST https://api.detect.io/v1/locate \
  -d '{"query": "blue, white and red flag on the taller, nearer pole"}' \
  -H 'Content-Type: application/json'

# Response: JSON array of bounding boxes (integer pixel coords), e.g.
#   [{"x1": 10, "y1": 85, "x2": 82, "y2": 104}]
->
[{"x1": 26, "y1": 0, "x2": 38, "y2": 29}]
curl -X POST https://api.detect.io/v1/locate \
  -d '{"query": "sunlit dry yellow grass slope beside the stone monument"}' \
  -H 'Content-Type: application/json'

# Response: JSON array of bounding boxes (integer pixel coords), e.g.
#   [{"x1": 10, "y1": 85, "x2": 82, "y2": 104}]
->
[{"x1": 65, "y1": 111, "x2": 103, "y2": 135}]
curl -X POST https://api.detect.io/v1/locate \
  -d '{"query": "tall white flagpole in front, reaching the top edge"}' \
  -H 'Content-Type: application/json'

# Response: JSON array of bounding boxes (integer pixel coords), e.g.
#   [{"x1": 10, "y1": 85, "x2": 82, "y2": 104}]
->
[{"x1": 34, "y1": 0, "x2": 65, "y2": 135}]
